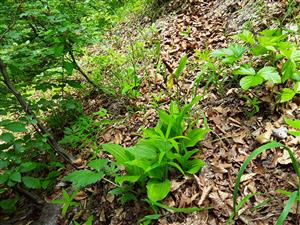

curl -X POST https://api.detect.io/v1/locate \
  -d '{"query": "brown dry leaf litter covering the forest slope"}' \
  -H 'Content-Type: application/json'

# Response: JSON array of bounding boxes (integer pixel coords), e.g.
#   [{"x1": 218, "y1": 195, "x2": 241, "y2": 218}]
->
[{"x1": 1, "y1": 0, "x2": 300, "y2": 225}]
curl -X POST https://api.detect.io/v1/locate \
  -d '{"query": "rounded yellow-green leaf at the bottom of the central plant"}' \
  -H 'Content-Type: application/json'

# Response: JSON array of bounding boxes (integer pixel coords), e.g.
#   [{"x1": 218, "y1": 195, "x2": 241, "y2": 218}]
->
[{"x1": 147, "y1": 179, "x2": 171, "y2": 202}]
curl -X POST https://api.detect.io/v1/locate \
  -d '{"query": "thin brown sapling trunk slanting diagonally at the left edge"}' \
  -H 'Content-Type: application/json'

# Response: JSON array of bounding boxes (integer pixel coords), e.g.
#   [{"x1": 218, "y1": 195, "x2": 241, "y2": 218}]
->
[{"x1": 0, "y1": 59, "x2": 75, "y2": 165}]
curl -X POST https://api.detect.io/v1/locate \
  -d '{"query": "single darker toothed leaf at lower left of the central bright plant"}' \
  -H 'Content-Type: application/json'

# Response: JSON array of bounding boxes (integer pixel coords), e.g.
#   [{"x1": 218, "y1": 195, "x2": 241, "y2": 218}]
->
[{"x1": 63, "y1": 170, "x2": 104, "y2": 188}]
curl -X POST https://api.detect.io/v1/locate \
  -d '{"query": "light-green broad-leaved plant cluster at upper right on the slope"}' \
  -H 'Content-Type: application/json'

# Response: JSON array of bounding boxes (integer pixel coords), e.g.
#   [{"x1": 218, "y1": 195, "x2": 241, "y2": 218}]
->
[{"x1": 211, "y1": 29, "x2": 300, "y2": 102}]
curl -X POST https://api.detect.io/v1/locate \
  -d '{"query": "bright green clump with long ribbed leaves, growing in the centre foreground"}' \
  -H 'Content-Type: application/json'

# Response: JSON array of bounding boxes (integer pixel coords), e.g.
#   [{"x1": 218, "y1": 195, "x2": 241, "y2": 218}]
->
[{"x1": 102, "y1": 100, "x2": 210, "y2": 202}]
